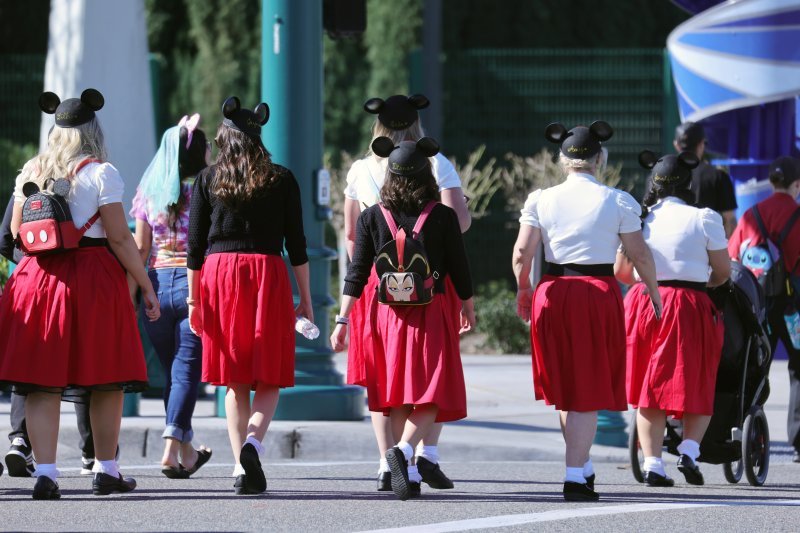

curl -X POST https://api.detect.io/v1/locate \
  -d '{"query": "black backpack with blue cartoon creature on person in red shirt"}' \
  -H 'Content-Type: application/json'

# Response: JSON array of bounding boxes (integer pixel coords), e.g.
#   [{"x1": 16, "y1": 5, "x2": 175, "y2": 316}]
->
[{"x1": 739, "y1": 205, "x2": 800, "y2": 298}]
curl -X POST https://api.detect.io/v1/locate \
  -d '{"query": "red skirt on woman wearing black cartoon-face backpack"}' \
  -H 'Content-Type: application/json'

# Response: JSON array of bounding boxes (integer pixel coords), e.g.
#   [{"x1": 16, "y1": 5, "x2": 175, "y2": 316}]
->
[{"x1": 365, "y1": 286, "x2": 467, "y2": 422}]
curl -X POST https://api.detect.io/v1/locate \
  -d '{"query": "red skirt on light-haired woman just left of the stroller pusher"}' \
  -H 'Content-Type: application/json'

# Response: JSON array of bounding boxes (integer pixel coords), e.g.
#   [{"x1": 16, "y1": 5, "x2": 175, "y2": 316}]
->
[{"x1": 531, "y1": 276, "x2": 628, "y2": 412}]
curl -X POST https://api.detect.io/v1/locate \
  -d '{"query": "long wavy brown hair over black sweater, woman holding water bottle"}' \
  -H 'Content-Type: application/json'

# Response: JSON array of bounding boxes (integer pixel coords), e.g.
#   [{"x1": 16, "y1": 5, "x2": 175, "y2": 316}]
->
[{"x1": 212, "y1": 124, "x2": 279, "y2": 208}]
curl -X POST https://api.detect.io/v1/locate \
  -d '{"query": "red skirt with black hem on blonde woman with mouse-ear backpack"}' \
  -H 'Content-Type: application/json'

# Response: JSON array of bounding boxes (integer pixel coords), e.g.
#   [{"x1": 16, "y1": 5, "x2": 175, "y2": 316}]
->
[{"x1": 0, "y1": 246, "x2": 147, "y2": 391}]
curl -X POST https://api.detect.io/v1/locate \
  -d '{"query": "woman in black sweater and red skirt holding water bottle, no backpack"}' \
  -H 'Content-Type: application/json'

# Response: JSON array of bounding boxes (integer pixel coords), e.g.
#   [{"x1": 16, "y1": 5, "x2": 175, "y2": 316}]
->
[{"x1": 187, "y1": 96, "x2": 314, "y2": 494}]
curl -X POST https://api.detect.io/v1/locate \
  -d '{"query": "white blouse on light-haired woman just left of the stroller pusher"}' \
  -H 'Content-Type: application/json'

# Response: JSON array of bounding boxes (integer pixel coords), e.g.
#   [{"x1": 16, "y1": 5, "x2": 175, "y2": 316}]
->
[{"x1": 519, "y1": 173, "x2": 642, "y2": 265}]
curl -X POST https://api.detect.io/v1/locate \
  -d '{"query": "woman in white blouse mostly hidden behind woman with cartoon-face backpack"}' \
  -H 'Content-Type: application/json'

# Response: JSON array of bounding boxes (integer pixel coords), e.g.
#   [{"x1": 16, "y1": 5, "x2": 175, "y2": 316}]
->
[{"x1": 344, "y1": 94, "x2": 471, "y2": 491}]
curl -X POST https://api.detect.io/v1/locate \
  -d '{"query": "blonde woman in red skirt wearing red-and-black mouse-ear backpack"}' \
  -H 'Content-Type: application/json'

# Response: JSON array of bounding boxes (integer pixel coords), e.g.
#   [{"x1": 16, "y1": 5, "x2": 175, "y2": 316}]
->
[{"x1": 0, "y1": 89, "x2": 159, "y2": 499}]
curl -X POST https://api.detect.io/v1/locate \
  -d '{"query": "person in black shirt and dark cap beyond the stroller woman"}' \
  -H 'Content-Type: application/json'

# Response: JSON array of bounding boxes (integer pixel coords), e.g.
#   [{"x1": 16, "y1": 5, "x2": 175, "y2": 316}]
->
[{"x1": 672, "y1": 122, "x2": 737, "y2": 237}]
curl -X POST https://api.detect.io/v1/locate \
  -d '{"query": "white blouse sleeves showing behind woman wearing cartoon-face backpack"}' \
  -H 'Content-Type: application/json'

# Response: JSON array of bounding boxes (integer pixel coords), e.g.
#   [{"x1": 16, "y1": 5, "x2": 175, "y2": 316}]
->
[{"x1": 344, "y1": 154, "x2": 461, "y2": 211}]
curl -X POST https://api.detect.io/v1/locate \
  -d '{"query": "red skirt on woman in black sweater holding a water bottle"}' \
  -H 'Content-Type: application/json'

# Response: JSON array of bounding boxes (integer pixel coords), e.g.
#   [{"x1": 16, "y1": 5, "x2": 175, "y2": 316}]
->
[{"x1": 200, "y1": 253, "x2": 295, "y2": 389}]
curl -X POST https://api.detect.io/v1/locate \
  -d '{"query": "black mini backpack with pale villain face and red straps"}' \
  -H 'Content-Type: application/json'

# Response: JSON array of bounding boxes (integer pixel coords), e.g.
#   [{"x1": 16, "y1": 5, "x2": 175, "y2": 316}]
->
[{"x1": 375, "y1": 201, "x2": 436, "y2": 305}]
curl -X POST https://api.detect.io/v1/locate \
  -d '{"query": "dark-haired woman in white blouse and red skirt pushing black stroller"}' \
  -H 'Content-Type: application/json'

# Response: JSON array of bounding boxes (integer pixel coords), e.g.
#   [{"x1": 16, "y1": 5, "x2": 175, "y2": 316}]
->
[{"x1": 615, "y1": 151, "x2": 730, "y2": 487}]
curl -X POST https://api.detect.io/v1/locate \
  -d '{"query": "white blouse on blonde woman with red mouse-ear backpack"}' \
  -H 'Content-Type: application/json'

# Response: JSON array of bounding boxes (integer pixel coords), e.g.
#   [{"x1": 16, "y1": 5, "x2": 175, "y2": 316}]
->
[{"x1": 14, "y1": 163, "x2": 125, "y2": 238}]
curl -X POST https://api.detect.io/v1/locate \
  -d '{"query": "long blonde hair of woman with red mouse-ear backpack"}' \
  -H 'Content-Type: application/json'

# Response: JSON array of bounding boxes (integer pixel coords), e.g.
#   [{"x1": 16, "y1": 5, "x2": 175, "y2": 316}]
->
[{"x1": 22, "y1": 117, "x2": 108, "y2": 187}]
